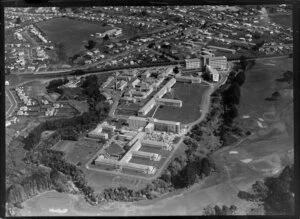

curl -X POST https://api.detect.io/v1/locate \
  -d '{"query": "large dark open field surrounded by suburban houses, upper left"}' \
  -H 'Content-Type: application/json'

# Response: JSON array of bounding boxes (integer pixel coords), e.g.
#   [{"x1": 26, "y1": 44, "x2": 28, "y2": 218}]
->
[{"x1": 36, "y1": 18, "x2": 110, "y2": 56}]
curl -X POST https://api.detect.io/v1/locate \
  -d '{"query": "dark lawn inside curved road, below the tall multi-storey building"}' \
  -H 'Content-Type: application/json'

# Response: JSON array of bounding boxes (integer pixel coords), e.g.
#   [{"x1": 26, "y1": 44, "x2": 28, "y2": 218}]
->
[{"x1": 150, "y1": 83, "x2": 207, "y2": 124}]
